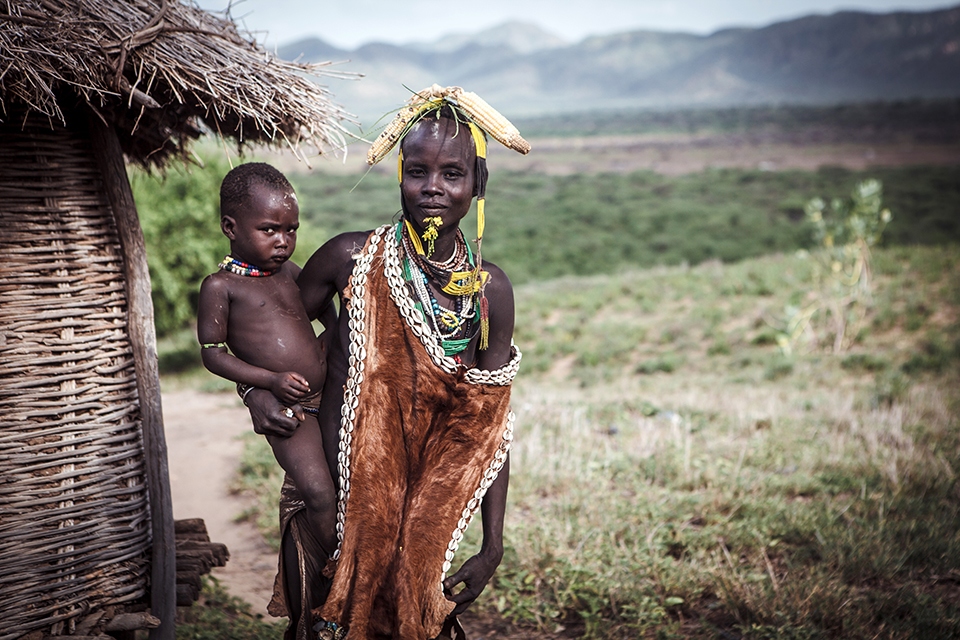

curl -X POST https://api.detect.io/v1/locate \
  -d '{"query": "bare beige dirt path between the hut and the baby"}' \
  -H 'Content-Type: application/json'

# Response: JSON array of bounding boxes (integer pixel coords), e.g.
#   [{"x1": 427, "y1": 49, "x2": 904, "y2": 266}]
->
[{"x1": 163, "y1": 389, "x2": 277, "y2": 616}]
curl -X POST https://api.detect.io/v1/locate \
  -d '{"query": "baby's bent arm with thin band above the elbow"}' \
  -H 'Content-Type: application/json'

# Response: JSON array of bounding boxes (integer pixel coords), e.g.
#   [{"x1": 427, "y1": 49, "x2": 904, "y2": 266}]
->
[{"x1": 197, "y1": 276, "x2": 310, "y2": 404}]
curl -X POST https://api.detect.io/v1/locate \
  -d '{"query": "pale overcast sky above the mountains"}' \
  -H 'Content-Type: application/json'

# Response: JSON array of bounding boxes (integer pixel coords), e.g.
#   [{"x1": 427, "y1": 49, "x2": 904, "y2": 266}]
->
[{"x1": 197, "y1": 0, "x2": 957, "y2": 49}]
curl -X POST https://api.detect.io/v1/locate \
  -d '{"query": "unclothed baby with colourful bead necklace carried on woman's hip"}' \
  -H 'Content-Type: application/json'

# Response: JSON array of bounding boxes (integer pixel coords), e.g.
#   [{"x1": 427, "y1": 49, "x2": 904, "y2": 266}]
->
[{"x1": 197, "y1": 163, "x2": 337, "y2": 555}]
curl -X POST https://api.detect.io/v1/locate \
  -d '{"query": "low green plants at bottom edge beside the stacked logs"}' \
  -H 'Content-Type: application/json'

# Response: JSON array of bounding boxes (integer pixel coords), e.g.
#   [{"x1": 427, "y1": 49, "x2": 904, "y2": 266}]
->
[{"x1": 176, "y1": 577, "x2": 286, "y2": 640}]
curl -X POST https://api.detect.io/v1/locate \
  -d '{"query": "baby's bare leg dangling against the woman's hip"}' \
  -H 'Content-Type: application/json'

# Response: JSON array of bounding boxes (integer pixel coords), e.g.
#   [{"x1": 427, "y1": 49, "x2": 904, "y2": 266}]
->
[{"x1": 267, "y1": 414, "x2": 337, "y2": 566}]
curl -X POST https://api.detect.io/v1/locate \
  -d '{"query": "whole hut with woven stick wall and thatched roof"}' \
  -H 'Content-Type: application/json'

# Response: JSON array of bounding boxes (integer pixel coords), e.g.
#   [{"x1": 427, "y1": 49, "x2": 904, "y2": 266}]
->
[{"x1": 0, "y1": 0, "x2": 346, "y2": 640}]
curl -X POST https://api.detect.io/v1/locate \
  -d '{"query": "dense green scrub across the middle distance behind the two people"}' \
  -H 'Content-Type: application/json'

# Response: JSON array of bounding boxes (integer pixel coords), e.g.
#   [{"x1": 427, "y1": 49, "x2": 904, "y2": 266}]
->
[{"x1": 139, "y1": 148, "x2": 960, "y2": 340}]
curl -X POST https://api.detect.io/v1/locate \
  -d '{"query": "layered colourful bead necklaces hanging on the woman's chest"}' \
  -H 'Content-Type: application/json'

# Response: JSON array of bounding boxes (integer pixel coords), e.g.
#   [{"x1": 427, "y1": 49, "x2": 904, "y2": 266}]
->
[{"x1": 396, "y1": 222, "x2": 479, "y2": 356}]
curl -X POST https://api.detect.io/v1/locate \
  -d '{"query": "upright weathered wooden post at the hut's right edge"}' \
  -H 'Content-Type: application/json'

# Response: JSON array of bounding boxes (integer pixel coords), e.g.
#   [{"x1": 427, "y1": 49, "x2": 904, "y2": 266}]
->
[{"x1": 87, "y1": 114, "x2": 177, "y2": 640}]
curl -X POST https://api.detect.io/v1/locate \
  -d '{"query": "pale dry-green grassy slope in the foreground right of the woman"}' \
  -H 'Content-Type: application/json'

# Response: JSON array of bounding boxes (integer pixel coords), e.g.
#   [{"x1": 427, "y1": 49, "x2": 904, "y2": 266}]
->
[{"x1": 218, "y1": 247, "x2": 960, "y2": 638}]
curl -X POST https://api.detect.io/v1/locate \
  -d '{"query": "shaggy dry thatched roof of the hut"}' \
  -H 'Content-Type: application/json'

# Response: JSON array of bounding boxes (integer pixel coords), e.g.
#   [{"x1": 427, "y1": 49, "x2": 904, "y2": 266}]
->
[{"x1": 0, "y1": 0, "x2": 349, "y2": 165}]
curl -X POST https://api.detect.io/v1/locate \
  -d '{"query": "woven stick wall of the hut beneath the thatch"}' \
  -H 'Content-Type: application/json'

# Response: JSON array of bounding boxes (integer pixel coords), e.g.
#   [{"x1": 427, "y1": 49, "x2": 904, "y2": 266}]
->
[{"x1": 0, "y1": 112, "x2": 150, "y2": 640}]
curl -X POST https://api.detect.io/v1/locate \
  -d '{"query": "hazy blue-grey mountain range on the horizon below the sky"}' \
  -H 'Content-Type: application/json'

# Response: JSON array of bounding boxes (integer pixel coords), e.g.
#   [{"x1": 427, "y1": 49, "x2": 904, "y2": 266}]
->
[{"x1": 278, "y1": 6, "x2": 960, "y2": 123}]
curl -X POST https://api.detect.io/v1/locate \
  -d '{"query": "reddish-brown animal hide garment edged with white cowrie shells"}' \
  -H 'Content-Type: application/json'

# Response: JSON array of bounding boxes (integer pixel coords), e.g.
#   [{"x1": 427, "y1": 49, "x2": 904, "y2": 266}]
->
[{"x1": 319, "y1": 228, "x2": 520, "y2": 640}]
